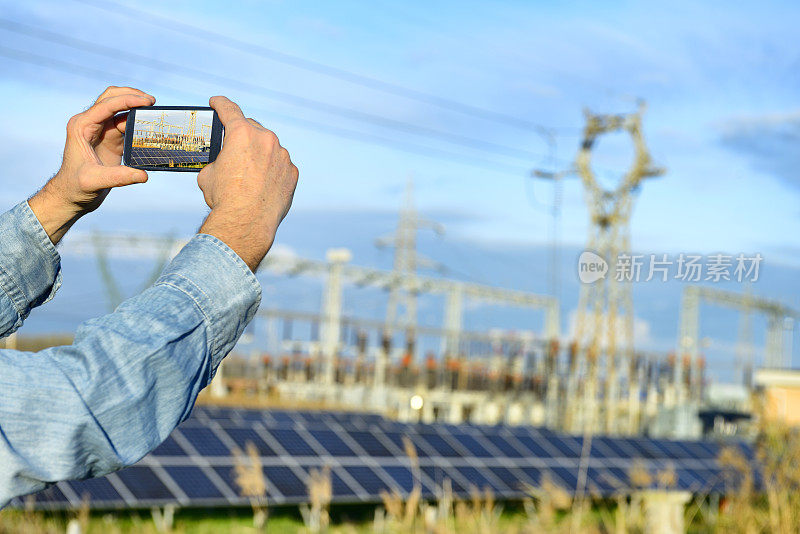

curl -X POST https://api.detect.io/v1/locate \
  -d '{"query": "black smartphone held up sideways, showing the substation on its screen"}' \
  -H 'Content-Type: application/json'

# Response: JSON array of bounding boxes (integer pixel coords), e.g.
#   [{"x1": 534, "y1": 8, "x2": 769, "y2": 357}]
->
[{"x1": 122, "y1": 106, "x2": 223, "y2": 172}]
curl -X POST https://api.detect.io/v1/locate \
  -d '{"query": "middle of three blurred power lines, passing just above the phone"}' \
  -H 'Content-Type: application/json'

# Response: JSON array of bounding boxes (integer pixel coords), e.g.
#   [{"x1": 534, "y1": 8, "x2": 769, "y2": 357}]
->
[{"x1": 0, "y1": 18, "x2": 560, "y2": 165}]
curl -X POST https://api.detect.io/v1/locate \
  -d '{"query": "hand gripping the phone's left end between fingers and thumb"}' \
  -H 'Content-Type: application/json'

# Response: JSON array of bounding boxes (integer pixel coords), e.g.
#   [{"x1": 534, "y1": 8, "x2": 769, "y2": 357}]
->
[{"x1": 28, "y1": 86, "x2": 156, "y2": 243}]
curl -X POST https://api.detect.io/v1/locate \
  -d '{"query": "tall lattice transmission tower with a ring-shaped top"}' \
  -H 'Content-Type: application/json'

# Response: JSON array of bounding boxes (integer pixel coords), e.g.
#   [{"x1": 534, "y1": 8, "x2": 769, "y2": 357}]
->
[{"x1": 571, "y1": 103, "x2": 664, "y2": 433}]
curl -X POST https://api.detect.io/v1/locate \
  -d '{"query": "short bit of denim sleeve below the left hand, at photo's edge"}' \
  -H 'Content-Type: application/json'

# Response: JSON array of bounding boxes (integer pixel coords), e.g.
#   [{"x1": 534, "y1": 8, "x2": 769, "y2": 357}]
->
[{"x1": 0, "y1": 201, "x2": 61, "y2": 338}]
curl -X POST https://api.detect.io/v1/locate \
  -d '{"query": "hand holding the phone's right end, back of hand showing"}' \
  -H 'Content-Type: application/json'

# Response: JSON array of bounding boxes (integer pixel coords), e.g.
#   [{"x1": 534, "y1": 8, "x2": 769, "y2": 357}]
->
[{"x1": 197, "y1": 96, "x2": 298, "y2": 272}]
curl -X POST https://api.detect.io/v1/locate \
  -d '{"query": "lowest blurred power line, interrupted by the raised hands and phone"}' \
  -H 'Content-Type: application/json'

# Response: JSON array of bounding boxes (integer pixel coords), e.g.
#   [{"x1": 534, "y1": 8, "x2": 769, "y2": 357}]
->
[{"x1": 0, "y1": 46, "x2": 526, "y2": 176}]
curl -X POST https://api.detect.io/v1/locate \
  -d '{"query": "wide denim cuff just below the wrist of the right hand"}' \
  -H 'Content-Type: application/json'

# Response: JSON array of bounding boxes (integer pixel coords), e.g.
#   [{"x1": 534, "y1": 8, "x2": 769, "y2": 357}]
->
[{"x1": 156, "y1": 234, "x2": 261, "y2": 377}]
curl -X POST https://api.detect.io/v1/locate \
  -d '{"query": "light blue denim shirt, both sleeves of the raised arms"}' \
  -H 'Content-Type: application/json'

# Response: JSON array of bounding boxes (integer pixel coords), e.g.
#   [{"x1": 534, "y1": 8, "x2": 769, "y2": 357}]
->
[{"x1": 0, "y1": 202, "x2": 261, "y2": 508}]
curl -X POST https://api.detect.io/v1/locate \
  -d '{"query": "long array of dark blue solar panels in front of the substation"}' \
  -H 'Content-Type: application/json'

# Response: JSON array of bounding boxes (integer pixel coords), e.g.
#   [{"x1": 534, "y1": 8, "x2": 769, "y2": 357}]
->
[{"x1": 16, "y1": 406, "x2": 752, "y2": 509}]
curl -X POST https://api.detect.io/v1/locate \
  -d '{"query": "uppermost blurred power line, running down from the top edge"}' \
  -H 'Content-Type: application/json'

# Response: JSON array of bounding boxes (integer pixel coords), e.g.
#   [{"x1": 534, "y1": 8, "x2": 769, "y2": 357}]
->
[{"x1": 70, "y1": 0, "x2": 568, "y2": 134}]
